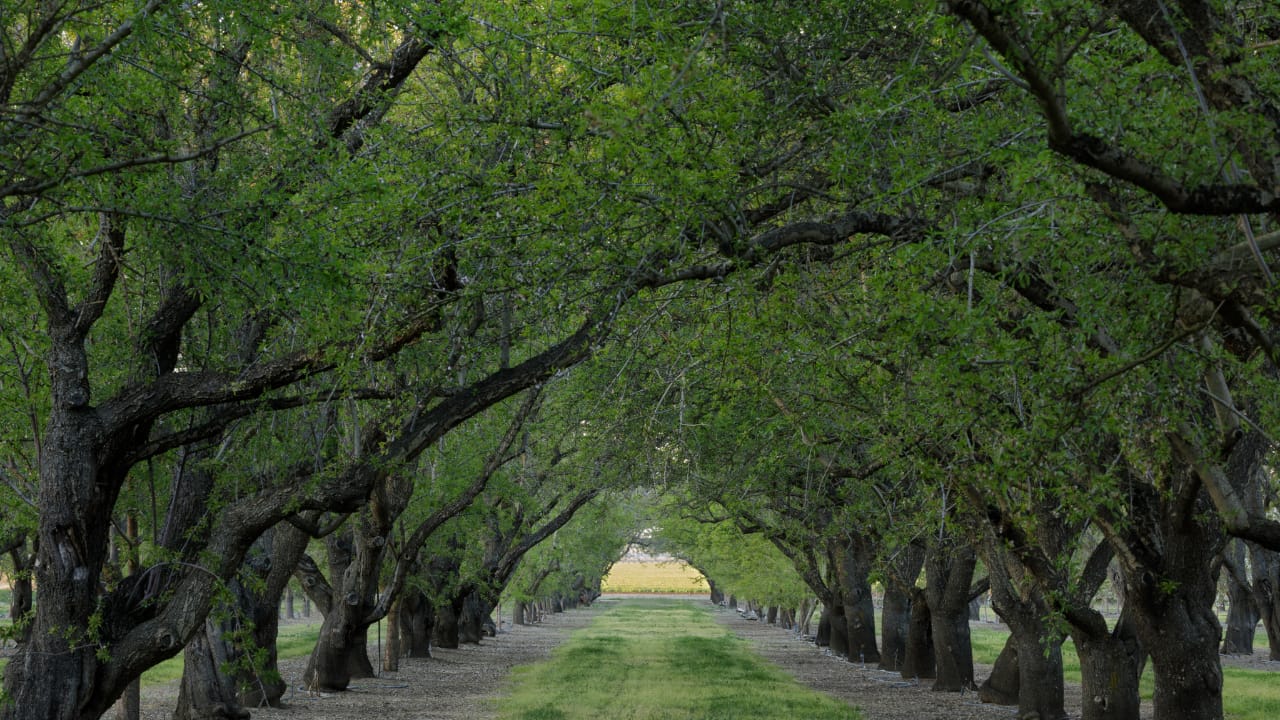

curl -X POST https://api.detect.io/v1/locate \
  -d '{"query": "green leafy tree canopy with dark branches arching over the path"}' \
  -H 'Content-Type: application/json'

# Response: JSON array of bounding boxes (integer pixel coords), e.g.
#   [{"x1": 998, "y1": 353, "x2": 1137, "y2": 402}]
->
[{"x1": 0, "y1": 0, "x2": 1280, "y2": 719}]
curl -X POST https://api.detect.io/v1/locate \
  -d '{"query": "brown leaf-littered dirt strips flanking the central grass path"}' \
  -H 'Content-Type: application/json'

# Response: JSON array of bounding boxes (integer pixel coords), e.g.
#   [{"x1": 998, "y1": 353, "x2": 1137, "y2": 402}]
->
[{"x1": 120, "y1": 601, "x2": 1280, "y2": 720}]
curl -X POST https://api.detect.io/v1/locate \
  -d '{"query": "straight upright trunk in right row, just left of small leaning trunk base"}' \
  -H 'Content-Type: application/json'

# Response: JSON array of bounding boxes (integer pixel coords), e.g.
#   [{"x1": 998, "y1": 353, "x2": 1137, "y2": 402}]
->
[{"x1": 924, "y1": 546, "x2": 977, "y2": 692}]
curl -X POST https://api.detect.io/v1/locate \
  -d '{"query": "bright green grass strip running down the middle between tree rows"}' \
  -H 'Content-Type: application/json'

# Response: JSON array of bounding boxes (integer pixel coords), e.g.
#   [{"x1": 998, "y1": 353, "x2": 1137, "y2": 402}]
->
[{"x1": 499, "y1": 598, "x2": 859, "y2": 720}]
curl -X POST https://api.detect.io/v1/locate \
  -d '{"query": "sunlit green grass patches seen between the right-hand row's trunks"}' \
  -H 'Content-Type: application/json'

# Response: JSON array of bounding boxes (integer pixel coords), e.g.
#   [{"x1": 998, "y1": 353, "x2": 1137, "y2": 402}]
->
[{"x1": 970, "y1": 628, "x2": 1280, "y2": 720}]
